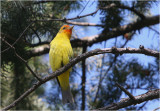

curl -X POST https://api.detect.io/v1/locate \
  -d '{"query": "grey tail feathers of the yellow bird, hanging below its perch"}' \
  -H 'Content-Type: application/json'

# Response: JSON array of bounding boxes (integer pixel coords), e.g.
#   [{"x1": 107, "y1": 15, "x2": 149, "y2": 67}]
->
[{"x1": 62, "y1": 87, "x2": 74, "y2": 104}]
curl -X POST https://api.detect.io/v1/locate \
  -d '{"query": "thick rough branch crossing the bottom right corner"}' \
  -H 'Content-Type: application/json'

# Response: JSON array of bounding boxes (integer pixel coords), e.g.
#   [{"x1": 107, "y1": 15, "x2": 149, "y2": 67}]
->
[{"x1": 97, "y1": 89, "x2": 160, "y2": 110}]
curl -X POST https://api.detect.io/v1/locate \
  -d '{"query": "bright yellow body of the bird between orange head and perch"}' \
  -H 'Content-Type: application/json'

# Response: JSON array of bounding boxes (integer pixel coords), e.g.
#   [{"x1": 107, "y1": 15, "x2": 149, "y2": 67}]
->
[{"x1": 49, "y1": 34, "x2": 73, "y2": 71}]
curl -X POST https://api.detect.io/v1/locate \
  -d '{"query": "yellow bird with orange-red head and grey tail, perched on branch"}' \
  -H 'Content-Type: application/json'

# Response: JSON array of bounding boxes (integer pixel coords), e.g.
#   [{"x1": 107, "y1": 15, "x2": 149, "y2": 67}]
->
[{"x1": 49, "y1": 25, "x2": 74, "y2": 104}]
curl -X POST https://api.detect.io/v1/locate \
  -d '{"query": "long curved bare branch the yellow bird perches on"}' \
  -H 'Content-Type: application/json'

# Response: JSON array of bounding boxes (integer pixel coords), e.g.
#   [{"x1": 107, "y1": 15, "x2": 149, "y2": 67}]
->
[{"x1": 3, "y1": 48, "x2": 159, "y2": 110}]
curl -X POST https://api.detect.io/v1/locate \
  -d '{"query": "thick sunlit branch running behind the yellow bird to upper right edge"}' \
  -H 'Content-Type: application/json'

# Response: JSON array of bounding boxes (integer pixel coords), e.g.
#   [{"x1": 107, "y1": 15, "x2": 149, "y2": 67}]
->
[{"x1": 25, "y1": 15, "x2": 160, "y2": 58}]
